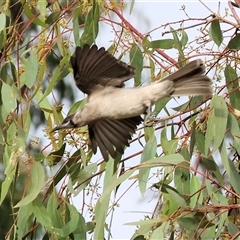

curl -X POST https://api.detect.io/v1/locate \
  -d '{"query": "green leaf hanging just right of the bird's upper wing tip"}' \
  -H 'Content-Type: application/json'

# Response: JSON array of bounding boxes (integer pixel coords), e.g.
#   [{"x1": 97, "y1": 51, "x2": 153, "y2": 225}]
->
[{"x1": 130, "y1": 44, "x2": 143, "y2": 86}]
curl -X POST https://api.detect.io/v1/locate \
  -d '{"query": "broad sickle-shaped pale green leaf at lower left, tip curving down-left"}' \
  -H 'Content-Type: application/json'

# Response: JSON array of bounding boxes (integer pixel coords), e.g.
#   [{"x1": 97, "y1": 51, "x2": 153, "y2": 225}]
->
[{"x1": 15, "y1": 162, "x2": 45, "y2": 208}]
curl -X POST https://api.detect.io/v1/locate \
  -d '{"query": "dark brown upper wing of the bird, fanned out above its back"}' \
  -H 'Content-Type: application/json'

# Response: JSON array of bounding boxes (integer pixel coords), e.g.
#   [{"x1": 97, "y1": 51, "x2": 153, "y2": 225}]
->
[{"x1": 70, "y1": 44, "x2": 135, "y2": 94}]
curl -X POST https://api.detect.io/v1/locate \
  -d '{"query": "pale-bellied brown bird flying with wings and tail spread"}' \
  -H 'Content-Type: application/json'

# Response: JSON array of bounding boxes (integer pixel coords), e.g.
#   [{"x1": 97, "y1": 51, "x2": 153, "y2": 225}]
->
[{"x1": 51, "y1": 44, "x2": 212, "y2": 161}]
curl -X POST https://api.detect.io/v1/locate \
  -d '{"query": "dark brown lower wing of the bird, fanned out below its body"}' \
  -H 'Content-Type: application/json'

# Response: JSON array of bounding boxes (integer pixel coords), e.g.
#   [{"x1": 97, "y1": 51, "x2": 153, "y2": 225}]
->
[{"x1": 89, "y1": 116, "x2": 143, "y2": 161}]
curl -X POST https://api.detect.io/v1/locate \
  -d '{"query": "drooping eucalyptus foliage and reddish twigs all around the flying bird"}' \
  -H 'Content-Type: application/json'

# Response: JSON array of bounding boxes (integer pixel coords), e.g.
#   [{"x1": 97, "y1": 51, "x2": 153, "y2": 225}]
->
[{"x1": 0, "y1": 0, "x2": 240, "y2": 239}]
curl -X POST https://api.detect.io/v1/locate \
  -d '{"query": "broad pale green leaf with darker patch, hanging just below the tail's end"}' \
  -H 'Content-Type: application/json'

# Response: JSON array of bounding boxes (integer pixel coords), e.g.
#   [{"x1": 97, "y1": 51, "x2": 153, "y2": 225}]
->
[{"x1": 205, "y1": 95, "x2": 228, "y2": 156}]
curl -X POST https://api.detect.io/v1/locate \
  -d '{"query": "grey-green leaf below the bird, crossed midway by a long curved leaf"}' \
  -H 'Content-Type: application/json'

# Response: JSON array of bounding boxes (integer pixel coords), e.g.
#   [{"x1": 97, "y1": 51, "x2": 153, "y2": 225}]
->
[{"x1": 138, "y1": 134, "x2": 157, "y2": 194}]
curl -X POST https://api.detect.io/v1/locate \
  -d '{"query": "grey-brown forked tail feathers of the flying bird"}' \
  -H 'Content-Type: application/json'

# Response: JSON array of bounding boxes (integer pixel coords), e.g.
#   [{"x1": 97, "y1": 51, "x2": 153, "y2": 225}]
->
[{"x1": 161, "y1": 59, "x2": 212, "y2": 96}]
